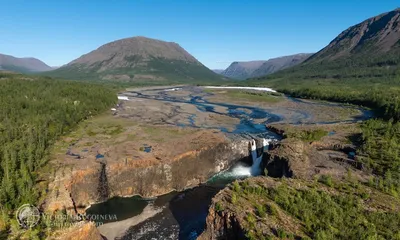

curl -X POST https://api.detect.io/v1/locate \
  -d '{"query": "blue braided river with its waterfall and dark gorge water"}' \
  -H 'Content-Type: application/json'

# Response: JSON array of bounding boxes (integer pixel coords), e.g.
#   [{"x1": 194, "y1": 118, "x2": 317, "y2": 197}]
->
[{"x1": 86, "y1": 87, "x2": 372, "y2": 240}]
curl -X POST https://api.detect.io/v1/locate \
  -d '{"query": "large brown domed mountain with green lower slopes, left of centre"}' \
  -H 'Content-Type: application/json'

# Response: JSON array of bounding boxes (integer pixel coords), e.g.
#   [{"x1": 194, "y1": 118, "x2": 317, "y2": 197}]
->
[{"x1": 49, "y1": 37, "x2": 224, "y2": 83}]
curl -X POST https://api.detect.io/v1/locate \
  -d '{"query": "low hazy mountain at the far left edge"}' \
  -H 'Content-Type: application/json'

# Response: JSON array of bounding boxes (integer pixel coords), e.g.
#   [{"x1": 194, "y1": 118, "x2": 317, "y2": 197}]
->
[{"x1": 0, "y1": 54, "x2": 52, "y2": 73}]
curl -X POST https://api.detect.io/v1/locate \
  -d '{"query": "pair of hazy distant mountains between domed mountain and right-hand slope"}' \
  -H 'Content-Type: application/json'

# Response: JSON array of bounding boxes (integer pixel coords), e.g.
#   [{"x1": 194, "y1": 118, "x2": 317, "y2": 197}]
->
[{"x1": 220, "y1": 53, "x2": 312, "y2": 80}]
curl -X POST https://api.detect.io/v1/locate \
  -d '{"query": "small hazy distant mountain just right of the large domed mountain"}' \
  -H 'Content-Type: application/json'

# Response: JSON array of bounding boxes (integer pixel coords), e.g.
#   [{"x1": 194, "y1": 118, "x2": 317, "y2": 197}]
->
[{"x1": 221, "y1": 61, "x2": 265, "y2": 80}]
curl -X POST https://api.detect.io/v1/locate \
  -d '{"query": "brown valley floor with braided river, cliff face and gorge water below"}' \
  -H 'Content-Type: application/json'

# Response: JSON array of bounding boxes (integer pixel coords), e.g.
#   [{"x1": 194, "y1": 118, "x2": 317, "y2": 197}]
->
[{"x1": 43, "y1": 86, "x2": 372, "y2": 239}]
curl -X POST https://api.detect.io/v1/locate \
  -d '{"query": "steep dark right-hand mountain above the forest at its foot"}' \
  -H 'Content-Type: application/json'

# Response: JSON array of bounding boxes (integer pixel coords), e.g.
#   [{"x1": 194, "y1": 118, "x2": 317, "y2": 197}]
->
[{"x1": 251, "y1": 8, "x2": 400, "y2": 88}]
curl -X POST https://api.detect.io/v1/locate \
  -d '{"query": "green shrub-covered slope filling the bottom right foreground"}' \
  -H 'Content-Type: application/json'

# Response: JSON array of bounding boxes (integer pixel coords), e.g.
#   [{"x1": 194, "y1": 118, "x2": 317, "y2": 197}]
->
[{"x1": 225, "y1": 178, "x2": 400, "y2": 240}]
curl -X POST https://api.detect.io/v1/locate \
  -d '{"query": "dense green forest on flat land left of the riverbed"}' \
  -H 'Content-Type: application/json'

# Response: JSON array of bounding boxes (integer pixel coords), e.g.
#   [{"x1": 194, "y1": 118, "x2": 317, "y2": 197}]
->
[{"x1": 0, "y1": 73, "x2": 117, "y2": 237}]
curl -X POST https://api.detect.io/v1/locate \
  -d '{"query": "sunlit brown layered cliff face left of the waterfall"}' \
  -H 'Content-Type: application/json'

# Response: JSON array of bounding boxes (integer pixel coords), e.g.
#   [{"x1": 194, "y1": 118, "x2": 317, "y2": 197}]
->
[{"x1": 46, "y1": 140, "x2": 248, "y2": 212}]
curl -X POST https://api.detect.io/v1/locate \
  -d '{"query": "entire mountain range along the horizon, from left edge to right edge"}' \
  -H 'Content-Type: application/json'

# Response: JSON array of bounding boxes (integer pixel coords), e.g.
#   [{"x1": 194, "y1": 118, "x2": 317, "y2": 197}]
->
[{"x1": 7, "y1": 9, "x2": 400, "y2": 83}]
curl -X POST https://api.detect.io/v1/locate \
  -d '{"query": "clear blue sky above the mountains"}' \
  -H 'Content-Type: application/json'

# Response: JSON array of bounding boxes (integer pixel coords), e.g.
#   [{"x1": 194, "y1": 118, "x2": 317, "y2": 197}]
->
[{"x1": 0, "y1": 0, "x2": 400, "y2": 69}]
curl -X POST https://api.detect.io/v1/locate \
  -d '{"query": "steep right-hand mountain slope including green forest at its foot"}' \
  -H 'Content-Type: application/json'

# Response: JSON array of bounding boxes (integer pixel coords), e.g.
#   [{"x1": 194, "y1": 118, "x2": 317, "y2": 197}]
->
[{"x1": 246, "y1": 9, "x2": 400, "y2": 120}]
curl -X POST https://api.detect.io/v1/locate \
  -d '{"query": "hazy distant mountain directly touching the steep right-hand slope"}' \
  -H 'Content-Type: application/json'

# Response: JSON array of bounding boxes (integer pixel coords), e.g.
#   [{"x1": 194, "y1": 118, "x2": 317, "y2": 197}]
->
[{"x1": 249, "y1": 53, "x2": 312, "y2": 77}]
